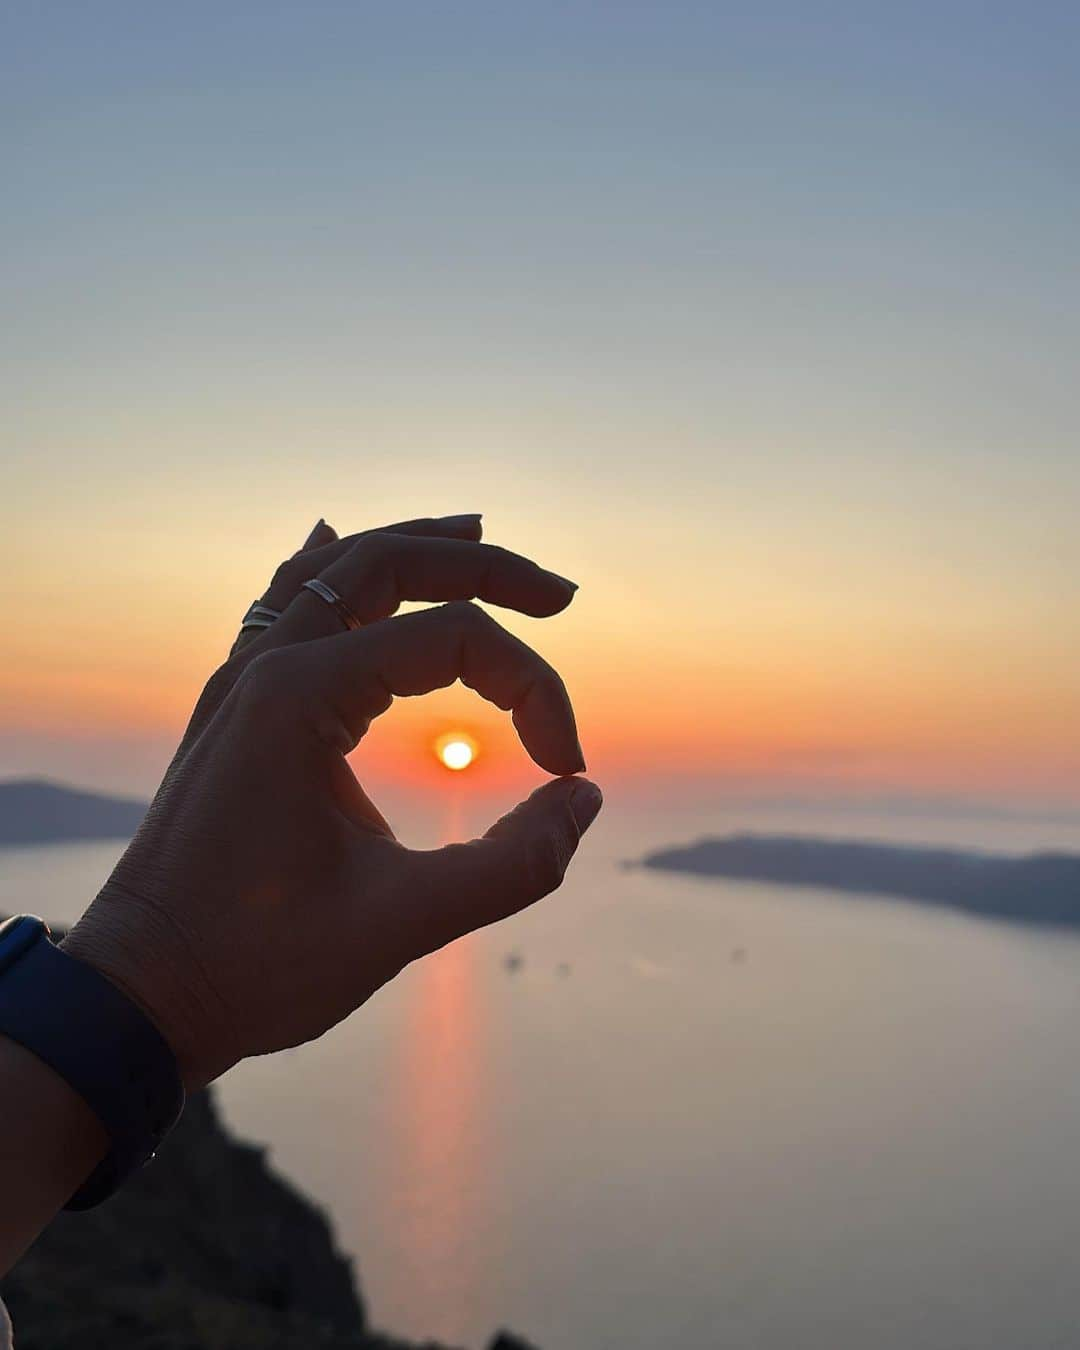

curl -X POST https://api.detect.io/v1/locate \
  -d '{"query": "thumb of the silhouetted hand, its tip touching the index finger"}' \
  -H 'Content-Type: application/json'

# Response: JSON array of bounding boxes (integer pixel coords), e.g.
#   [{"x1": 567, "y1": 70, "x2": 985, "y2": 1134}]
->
[{"x1": 410, "y1": 778, "x2": 603, "y2": 956}]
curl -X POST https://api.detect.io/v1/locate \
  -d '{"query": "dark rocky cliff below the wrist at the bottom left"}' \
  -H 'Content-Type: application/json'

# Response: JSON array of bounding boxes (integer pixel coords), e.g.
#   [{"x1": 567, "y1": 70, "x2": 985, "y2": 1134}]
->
[{"x1": 0, "y1": 1094, "x2": 528, "y2": 1350}]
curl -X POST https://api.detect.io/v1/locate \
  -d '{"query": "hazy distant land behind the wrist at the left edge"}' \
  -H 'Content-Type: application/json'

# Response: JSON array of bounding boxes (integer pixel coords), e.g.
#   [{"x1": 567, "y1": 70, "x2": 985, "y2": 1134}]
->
[{"x1": 0, "y1": 779, "x2": 146, "y2": 848}]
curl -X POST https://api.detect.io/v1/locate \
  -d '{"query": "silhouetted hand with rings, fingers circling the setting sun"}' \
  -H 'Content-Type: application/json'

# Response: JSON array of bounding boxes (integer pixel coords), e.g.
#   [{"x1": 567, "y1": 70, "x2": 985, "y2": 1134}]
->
[{"x1": 65, "y1": 517, "x2": 601, "y2": 1088}]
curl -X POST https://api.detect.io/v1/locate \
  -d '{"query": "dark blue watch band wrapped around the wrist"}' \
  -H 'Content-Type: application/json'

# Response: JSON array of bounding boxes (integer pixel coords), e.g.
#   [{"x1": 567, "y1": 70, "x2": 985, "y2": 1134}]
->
[{"x1": 0, "y1": 914, "x2": 184, "y2": 1210}]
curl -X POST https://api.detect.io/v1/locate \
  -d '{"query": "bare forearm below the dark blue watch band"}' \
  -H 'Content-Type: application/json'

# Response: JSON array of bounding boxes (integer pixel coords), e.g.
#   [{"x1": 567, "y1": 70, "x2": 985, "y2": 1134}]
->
[{"x1": 0, "y1": 1035, "x2": 107, "y2": 1274}]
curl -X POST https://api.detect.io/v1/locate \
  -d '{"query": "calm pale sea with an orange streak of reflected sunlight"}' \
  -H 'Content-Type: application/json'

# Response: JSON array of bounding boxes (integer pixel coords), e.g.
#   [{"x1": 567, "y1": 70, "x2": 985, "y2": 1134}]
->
[{"x1": 0, "y1": 802, "x2": 1080, "y2": 1350}]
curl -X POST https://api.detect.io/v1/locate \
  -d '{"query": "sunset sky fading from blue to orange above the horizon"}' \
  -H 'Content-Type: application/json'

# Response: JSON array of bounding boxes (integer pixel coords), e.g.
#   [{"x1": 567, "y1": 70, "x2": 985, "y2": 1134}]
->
[{"x1": 0, "y1": 0, "x2": 1080, "y2": 810}]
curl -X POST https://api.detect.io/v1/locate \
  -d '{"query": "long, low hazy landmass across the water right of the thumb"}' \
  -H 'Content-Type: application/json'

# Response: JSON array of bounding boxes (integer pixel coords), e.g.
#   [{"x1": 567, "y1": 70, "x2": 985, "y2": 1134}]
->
[{"x1": 641, "y1": 834, "x2": 1080, "y2": 926}]
